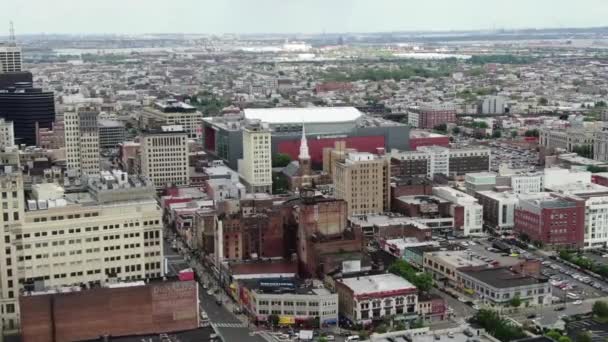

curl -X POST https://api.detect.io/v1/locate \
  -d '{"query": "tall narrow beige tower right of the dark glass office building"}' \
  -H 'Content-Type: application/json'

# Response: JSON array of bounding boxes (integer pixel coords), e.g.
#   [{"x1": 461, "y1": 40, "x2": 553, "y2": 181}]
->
[{"x1": 64, "y1": 106, "x2": 100, "y2": 176}]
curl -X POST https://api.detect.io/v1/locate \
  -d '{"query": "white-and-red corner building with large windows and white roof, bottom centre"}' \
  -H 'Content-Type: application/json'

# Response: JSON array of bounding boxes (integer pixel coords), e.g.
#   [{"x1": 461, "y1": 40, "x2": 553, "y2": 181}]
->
[{"x1": 336, "y1": 273, "x2": 418, "y2": 323}]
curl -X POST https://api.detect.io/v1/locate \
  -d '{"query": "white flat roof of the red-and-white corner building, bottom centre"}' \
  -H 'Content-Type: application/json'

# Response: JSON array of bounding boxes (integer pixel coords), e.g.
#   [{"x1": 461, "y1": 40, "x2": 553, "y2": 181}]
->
[{"x1": 338, "y1": 273, "x2": 416, "y2": 295}]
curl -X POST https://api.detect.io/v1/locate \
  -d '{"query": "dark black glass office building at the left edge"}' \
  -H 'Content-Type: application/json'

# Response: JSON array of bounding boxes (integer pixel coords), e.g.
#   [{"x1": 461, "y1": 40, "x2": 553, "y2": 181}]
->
[{"x1": 0, "y1": 82, "x2": 55, "y2": 145}]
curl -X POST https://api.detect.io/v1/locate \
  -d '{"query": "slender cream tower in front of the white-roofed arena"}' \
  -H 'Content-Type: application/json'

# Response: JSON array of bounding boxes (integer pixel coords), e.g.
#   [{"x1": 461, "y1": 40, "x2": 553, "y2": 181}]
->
[{"x1": 238, "y1": 120, "x2": 272, "y2": 193}]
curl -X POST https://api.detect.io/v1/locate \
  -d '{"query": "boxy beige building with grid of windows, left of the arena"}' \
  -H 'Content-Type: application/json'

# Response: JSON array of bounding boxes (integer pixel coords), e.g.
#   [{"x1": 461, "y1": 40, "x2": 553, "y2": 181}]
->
[{"x1": 139, "y1": 125, "x2": 189, "y2": 188}]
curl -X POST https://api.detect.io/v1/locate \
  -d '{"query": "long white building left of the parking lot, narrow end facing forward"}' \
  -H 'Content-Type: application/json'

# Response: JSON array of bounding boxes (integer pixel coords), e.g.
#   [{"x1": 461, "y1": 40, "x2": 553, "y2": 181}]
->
[{"x1": 433, "y1": 186, "x2": 483, "y2": 236}]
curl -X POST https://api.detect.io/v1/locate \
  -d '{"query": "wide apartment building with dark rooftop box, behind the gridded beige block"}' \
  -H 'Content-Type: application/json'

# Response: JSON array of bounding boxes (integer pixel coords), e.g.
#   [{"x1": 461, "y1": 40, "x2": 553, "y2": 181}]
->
[{"x1": 139, "y1": 99, "x2": 203, "y2": 139}]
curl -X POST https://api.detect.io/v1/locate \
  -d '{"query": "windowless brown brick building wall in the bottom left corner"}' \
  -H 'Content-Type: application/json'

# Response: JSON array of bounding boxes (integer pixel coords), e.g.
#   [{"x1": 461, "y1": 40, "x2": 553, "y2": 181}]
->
[{"x1": 19, "y1": 281, "x2": 199, "y2": 342}]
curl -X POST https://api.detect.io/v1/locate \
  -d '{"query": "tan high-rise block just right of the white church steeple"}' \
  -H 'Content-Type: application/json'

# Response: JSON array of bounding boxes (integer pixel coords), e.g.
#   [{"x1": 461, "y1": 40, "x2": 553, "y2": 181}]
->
[{"x1": 332, "y1": 152, "x2": 391, "y2": 216}]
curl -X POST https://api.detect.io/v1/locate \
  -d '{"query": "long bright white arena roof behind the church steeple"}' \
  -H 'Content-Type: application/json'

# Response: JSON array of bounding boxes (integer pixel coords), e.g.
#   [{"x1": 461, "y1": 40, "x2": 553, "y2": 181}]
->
[{"x1": 244, "y1": 107, "x2": 363, "y2": 124}]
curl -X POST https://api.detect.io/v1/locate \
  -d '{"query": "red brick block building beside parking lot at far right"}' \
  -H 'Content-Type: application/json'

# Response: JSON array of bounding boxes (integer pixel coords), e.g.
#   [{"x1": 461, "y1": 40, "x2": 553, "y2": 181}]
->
[{"x1": 514, "y1": 193, "x2": 585, "y2": 247}]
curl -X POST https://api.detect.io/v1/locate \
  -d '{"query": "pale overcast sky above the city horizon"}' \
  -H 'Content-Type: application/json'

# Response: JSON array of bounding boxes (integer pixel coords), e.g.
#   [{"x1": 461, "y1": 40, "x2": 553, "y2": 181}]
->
[{"x1": 0, "y1": 0, "x2": 608, "y2": 35}]
